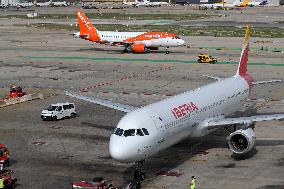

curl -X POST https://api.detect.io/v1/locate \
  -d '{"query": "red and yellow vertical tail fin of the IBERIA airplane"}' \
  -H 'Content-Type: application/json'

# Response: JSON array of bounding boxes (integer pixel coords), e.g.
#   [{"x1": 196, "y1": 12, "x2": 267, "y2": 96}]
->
[{"x1": 237, "y1": 24, "x2": 251, "y2": 76}]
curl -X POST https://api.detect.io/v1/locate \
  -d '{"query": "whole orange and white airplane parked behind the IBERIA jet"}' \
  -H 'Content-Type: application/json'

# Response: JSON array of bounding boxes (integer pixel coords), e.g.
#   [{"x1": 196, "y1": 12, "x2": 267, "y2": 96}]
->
[{"x1": 74, "y1": 11, "x2": 185, "y2": 54}]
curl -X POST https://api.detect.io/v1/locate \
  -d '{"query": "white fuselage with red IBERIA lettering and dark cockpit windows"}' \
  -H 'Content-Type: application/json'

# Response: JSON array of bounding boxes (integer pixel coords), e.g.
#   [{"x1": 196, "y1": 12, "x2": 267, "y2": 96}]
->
[{"x1": 109, "y1": 75, "x2": 249, "y2": 162}]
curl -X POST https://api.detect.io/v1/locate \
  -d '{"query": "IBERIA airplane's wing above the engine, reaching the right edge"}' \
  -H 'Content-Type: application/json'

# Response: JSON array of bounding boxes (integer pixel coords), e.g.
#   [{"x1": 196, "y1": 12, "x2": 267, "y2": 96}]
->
[{"x1": 206, "y1": 114, "x2": 284, "y2": 130}]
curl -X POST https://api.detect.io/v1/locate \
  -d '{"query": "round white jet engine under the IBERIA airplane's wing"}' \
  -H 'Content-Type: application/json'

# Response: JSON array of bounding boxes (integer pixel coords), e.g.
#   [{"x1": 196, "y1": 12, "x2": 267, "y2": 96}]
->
[{"x1": 229, "y1": 128, "x2": 256, "y2": 155}]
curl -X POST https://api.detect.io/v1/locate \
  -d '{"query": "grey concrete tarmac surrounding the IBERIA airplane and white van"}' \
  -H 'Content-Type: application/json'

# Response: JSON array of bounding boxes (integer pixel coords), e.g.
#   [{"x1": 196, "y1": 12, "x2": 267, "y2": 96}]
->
[{"x1": 0, "y1": 7, "x2": 284, "y2": 189}]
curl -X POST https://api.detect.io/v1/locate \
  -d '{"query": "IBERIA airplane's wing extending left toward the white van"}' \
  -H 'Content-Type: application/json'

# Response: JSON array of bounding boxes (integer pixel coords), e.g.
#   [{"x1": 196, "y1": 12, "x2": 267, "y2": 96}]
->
[{"x1": 66, "y1": 91, "x2": 138, "y2": 112}]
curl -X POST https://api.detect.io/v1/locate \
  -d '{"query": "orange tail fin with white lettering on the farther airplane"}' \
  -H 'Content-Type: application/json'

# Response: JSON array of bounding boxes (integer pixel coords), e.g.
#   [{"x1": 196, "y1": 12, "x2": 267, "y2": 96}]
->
[{"x1": 76, "y1": 11, "x2": 100, "y2": 41}]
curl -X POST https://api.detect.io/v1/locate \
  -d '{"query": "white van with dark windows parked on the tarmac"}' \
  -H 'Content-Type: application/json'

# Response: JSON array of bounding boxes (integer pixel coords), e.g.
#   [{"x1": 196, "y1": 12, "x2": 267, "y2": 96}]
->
[{"x1": 41, "y1": 102, "x2": 76, "y2": 120}]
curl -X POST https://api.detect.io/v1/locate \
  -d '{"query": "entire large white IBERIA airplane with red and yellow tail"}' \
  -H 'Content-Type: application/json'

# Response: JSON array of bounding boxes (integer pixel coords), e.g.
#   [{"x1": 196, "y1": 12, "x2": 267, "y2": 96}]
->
[{"x1": 66, "y1": 25, "x2": 284, "y2": 180}]
